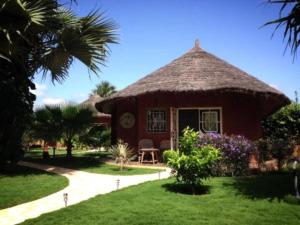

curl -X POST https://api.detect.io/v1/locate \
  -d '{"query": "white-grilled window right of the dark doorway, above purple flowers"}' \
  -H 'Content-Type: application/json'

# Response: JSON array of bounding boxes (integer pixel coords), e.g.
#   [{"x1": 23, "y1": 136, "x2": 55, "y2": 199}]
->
[{"x1": 199, "y1": 109, "x2": 221, "y2": 133}]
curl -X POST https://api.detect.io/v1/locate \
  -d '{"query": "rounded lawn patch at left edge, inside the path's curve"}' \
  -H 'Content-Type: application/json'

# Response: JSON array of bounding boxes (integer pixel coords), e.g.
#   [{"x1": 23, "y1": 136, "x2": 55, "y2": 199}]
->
[{"x1": 0, "y1": 166, "x2": 68, "y2": 209}]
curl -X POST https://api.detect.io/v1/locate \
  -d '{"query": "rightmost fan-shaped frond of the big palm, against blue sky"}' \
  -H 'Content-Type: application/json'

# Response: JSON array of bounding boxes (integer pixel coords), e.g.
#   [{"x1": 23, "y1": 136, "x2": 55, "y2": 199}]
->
[{"x1": 61, "y1": 11, "x2": 116, "y2": 73}]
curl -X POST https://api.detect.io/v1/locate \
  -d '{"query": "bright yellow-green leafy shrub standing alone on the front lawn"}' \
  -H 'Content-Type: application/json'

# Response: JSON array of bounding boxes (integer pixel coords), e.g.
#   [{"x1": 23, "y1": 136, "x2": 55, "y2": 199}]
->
[{"x1": 164, "y1": 129, "x2": 219, "y2": 193}]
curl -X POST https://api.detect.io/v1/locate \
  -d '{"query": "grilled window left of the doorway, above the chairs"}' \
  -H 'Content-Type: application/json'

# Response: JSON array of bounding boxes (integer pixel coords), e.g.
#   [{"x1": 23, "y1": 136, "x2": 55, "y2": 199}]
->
[{"x1": 147, "y1": 110, "x2": 167, "y2": 132}]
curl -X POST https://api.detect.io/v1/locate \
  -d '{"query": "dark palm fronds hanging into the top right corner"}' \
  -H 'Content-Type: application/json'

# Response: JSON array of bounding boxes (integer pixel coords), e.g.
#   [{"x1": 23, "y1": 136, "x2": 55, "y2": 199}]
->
[{"x1": 265, "y1": 0, "x2": 300, "y2": 58}]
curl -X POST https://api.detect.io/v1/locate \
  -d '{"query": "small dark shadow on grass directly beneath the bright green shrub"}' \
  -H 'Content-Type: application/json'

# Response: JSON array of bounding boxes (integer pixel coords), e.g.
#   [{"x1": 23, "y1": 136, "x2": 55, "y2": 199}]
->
[{"x1": 162, "y1": 182, "x2": 210, "y2": 195}]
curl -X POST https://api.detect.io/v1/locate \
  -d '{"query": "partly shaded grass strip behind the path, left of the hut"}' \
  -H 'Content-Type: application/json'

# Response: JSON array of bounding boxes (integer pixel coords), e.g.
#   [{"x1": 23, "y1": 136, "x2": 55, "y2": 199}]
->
[{"x1": 24, "y1": 151, "x2": 162, "y2": 175}]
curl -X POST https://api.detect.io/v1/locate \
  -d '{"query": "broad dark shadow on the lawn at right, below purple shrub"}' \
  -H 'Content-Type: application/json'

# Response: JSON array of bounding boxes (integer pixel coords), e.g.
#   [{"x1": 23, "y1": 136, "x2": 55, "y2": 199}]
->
[{"x1": 223, "y1": 173, "x2": 295, "y2": 201}]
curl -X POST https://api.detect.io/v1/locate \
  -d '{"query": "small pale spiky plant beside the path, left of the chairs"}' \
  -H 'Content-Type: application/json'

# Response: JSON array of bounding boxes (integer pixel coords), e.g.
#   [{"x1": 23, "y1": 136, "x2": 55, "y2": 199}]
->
[{"x1": 110, "y1": 140, "x2": 133, "y2": 170}]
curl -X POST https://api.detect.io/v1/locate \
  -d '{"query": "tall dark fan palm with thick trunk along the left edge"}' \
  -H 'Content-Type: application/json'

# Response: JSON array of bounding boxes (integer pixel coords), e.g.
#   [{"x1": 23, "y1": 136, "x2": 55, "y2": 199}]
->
[{"x1": 0, "y1": 0, "x2": 116, "y2": 169}]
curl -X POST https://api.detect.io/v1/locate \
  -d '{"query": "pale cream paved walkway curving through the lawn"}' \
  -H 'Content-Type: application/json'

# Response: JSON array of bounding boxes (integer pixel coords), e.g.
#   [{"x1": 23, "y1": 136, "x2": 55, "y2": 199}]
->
[{"x1": 0, "y1": 162, "x2": 170, "y2": 225}]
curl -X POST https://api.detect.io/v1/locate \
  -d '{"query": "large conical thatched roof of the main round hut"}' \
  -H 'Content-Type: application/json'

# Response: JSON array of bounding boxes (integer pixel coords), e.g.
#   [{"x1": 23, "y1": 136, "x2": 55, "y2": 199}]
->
[{"x1": 100, "y1": 41, "x2": 289, "y2": 104}]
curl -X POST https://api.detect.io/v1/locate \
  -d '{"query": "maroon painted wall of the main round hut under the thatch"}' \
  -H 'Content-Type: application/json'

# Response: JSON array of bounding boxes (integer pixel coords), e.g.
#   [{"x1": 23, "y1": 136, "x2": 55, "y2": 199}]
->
[{"x1": 113, "y1": 92, "x2": 267, "y2": 149}]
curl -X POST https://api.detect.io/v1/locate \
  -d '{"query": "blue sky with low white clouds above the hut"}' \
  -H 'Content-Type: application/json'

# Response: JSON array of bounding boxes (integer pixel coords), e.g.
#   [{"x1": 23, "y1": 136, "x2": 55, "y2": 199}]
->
[{"x1": 31, "y1": 0, "x2": 300, "y2": 106}]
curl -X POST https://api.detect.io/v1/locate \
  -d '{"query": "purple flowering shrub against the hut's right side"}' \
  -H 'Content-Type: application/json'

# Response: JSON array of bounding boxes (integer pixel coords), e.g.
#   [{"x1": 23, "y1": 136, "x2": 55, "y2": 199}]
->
[{"x1": 198, "y1": 133, "x2": 254, "y2": 175}]
